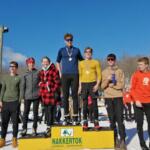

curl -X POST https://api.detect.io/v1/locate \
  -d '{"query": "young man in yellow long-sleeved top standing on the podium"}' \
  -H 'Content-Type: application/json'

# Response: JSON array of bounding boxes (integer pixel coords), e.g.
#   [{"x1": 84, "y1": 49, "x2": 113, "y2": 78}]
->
[{"x1": 79, "y1": 47, "x2": 101, "y2": 130}]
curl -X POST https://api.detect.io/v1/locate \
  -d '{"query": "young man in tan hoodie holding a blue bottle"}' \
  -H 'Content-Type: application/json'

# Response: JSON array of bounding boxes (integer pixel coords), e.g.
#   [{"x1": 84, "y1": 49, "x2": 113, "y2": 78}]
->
[{"x1": 101, "y1": 54, "x2": 126, "y2": 149}]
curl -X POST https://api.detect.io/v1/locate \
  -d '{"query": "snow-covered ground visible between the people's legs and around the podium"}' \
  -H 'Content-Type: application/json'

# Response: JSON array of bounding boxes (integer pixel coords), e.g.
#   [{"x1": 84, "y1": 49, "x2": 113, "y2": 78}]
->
[{"x1": 1, "y1": 102, "x2": 149, "y2": 150}]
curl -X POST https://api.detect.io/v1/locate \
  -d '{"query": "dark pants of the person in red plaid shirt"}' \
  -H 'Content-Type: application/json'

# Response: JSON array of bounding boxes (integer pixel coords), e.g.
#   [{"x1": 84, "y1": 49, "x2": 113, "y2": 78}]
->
[{"x1": 44, "y1": 104, "x2": 56, "y2": 126}]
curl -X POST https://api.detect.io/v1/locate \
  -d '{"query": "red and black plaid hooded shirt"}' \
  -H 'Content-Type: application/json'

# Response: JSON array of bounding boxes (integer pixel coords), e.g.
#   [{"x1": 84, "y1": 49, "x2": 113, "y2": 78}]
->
[{"x1": 39, "y1": 64, "x2": 60, "y2": 105}]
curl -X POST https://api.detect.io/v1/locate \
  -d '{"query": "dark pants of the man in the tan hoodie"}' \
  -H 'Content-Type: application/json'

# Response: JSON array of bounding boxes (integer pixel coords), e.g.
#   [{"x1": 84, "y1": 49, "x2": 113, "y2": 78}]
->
[{"x1": 105, "y1": 97, "x2": 126, "y2": 140}]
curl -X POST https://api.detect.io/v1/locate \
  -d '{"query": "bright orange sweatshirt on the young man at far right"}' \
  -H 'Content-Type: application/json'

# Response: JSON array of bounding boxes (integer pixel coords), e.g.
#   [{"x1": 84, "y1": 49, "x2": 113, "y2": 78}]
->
[{"x1": 130, "y1": 71, "x2": 150, "y2": 103}]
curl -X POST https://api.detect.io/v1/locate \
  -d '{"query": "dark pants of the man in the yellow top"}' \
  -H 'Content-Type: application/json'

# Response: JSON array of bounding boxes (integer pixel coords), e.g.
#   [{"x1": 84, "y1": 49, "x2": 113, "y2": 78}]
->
[{"x1": 81, "y1": 82, "x2": 98, "y2": 120}]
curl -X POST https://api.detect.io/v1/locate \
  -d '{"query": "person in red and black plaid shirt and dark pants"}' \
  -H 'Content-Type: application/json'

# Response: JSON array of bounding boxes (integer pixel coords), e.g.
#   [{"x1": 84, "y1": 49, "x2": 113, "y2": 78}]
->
[{"x1": 39, "y1": 57, "x2": 60, "y2": 136}]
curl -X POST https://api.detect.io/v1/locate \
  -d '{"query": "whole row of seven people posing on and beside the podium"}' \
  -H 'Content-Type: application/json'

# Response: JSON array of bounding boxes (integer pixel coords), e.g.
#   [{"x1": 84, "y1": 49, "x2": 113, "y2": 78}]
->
[{"x1": 0, "y1": 33, "x2": 150, "y2": 150}]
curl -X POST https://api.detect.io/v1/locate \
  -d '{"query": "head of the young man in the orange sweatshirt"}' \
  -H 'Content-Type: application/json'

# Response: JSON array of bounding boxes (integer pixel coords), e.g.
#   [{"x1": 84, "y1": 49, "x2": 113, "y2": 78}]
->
[{"x1": 137, "y1": 57, "x2": 149, "y2": 72}]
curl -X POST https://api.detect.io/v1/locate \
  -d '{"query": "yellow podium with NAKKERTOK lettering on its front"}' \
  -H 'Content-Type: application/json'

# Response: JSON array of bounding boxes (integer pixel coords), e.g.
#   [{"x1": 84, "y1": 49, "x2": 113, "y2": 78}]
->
[{"x1": 18, "y1": 126, "x2": 114, "y2": 150}]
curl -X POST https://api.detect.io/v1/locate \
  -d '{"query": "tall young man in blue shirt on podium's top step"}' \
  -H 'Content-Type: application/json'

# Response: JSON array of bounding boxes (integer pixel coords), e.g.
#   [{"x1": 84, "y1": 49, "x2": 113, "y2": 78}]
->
[{"x1": 56, "y1": 33, "x2": 83, "y2": 125}]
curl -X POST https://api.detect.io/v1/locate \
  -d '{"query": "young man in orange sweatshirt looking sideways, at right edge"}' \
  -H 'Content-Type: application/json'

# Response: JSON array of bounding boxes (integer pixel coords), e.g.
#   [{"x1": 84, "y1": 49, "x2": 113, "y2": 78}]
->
[{"x1": 131, "y1": 57, "x2": 150, "y2": 150}]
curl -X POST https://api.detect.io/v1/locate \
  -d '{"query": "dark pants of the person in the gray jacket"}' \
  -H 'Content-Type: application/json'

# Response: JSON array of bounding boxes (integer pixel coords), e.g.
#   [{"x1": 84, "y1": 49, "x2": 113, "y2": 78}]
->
[{"x1": 23, "y1": 99, "x2": 40, "y2": 129}]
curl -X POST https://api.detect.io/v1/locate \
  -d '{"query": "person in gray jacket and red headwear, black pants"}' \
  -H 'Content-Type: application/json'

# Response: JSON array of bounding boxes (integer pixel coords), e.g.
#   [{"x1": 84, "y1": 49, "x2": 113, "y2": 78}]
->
[{"x1": 21, "y1": 57, "x2": 40, "y2": 136}]
